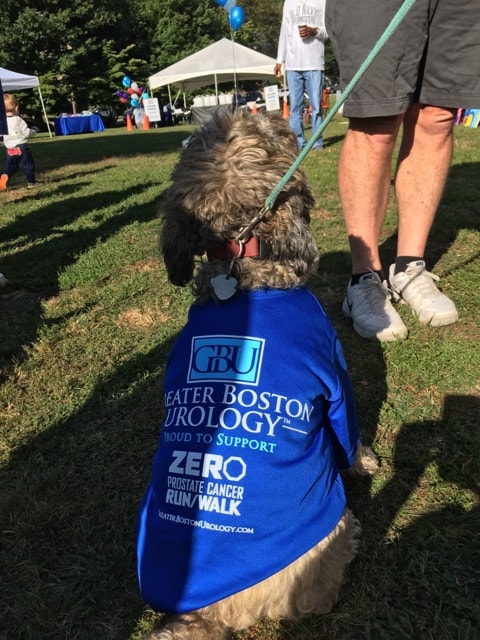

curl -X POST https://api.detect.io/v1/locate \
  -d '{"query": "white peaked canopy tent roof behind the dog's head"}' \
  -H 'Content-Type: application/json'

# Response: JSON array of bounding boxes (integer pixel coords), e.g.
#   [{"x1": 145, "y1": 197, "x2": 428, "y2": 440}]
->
[{"x1": 148, "y1": 38, "x2": 276, "y2": 101}]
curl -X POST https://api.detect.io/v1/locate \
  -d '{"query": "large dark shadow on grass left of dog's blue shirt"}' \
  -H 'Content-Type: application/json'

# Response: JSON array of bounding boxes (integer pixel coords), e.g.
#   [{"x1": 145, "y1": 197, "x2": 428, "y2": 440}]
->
[{"x1": 0, "y1": 339, "x2": 173, "y2": 640}]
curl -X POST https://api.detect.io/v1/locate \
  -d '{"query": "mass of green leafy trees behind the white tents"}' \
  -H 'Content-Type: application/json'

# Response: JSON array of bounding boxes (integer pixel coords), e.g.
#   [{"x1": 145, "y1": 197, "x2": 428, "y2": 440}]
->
[{"x1": 0, "y1": 0, "x2": 335, "y2": 121}]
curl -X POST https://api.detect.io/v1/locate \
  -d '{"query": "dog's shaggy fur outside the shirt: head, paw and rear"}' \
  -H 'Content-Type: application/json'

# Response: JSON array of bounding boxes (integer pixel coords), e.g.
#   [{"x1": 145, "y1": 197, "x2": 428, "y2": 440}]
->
[{"x1": 147, "y1": 111, "x2": 377, "y2": 640}]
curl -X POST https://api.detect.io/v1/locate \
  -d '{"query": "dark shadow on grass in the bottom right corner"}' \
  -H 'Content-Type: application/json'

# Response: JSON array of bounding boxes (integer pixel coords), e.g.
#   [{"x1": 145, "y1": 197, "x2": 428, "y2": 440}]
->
[{"x1": 268, "y1": 396, "x2": 480, "y2": 640}]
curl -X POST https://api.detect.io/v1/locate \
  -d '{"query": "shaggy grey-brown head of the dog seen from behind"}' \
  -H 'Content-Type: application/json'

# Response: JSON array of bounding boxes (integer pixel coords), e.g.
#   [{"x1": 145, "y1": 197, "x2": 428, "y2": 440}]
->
[{"x1": 161, "y1": 110, "x2": 318, "y2": 300}]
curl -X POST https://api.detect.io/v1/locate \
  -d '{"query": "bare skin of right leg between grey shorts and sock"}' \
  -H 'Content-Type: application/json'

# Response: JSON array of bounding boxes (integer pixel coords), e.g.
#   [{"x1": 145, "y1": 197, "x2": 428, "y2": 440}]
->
[{"x1": 395, "y1": 104, "x2": 454, "y2": 257}]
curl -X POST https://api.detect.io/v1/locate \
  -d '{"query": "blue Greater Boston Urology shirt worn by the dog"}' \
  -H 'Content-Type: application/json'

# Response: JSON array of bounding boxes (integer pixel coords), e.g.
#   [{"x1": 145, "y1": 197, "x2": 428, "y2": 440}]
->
[{"x1": 137, "y1": 288, "x2": 359, "y2": 612}]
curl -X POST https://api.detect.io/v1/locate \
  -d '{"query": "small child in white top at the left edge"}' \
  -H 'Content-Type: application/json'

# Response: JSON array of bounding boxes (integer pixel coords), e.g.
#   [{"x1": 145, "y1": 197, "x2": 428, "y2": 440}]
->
[{"x1": 0, "y1": 93, "x2": 38, "y2": 191}]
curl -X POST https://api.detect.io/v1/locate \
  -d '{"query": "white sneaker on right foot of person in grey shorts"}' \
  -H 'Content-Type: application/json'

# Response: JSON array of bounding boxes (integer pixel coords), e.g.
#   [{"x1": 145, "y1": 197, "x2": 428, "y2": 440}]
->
[{"x1": 389, "y1": 260, "x2": 458, "y2": 327}]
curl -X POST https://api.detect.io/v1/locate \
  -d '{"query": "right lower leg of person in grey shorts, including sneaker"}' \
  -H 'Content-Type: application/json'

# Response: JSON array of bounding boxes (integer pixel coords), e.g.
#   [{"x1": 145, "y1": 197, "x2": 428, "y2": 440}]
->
[{"x1": 389, "y1": 105, "x2": 458, "y2": 327}]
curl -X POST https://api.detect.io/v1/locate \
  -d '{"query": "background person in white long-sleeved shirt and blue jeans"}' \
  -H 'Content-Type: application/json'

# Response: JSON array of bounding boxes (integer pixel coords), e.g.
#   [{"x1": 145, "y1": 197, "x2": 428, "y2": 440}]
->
[{"x1": 274, "y1": 0, "x2": 328, "y2": 150}]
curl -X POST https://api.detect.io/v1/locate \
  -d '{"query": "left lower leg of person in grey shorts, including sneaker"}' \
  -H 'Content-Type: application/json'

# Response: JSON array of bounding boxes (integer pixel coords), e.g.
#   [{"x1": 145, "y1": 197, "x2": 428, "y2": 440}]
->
[{"x1": 338, "y1": 115, "x2": 408, "y2": 341}]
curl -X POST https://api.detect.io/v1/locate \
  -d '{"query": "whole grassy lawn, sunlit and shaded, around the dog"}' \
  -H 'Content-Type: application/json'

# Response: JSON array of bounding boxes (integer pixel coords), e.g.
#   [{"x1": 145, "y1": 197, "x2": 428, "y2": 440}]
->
[{"x1": 0, "y1": 117, "x2": 480, "y2": 640}]
